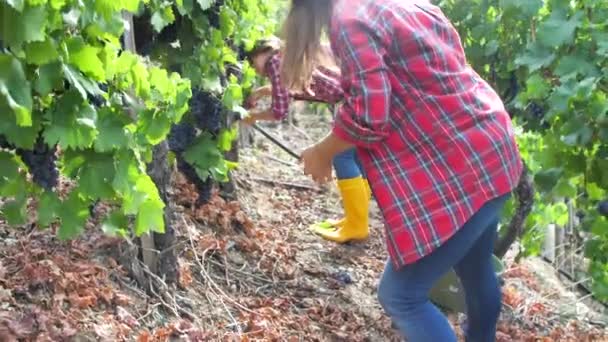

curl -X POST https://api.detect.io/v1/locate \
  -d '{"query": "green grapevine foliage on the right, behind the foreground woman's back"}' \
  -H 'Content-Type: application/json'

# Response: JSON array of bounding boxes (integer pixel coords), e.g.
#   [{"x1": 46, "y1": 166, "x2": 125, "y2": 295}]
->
[{"x1": 434, "y1": 0, "x2": 608, "y2": 299}]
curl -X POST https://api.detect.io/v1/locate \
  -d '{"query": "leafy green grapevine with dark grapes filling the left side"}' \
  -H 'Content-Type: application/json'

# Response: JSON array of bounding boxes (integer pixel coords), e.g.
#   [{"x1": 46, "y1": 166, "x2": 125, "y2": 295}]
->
[{"x1": 0, "y1": 0, "x2": 276, "y2": 243}]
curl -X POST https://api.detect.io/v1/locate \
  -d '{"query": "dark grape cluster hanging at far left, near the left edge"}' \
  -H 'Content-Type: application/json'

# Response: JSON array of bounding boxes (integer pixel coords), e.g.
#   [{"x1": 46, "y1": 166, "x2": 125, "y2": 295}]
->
[{"x1": 15, "y1": 136, "x2": 59, "y2": 190}]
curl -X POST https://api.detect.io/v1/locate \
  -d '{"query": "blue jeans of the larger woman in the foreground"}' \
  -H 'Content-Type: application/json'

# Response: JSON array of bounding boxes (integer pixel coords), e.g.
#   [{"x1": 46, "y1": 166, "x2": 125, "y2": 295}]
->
[{"x1": 378, "y1": 195, "x2": 509, "y2": 342}]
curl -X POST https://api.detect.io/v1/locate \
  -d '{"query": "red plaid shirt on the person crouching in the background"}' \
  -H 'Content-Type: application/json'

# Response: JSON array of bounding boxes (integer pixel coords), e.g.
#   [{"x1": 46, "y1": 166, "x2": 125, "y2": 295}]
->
[{"x1": 266, "y1": 53, "x2": 344, "y2": 120}]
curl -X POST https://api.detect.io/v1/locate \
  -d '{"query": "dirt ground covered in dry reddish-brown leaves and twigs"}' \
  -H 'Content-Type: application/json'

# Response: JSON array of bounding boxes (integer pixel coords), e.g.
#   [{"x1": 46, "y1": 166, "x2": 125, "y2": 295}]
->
[{"x1": 0, "y1": 105, "x2": 608, "y2": 342}]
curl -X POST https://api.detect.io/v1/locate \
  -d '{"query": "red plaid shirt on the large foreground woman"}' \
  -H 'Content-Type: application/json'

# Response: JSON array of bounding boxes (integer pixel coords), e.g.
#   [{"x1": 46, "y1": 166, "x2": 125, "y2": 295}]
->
[{"x1": 330, "y1": 0, "x2": 522, "y2": 268}]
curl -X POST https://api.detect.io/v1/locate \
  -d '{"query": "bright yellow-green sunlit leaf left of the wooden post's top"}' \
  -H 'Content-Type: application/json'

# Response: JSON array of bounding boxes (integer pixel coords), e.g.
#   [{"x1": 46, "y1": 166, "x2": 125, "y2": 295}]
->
[{"x1": 66, "y1": 38, "x2": 105, "y2": 81}]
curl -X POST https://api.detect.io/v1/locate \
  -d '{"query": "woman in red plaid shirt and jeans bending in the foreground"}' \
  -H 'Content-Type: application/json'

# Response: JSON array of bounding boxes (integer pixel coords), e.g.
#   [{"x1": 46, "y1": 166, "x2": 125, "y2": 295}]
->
[{"x1": 282, "y1": 0, "x2": 522, "y2": 342}]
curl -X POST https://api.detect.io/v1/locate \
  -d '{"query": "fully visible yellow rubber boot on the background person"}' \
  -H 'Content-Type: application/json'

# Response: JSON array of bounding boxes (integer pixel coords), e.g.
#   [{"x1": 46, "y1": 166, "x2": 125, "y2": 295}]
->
[{"x1": 315, "y1": 177, "x2": 370, "y2": 243}]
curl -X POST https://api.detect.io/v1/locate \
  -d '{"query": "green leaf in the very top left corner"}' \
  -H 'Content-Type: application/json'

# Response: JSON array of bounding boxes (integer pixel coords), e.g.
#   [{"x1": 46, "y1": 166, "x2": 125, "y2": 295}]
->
[{"x1": 0, "y1": 3, "x2": 48, "y2": 50}]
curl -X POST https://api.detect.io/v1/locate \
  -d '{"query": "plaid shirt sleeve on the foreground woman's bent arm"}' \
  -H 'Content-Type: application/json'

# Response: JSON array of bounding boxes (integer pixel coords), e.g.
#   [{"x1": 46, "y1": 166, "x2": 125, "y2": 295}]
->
[{"x1": 333, "y1": 18, "x2": 391, "y2": 147}]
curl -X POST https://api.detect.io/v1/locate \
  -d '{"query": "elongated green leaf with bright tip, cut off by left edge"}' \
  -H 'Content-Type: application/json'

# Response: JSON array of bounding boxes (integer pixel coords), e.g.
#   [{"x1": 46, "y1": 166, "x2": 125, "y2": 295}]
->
[{"x1": 0, "y1": 54, "x2": 33, "y2": 126}]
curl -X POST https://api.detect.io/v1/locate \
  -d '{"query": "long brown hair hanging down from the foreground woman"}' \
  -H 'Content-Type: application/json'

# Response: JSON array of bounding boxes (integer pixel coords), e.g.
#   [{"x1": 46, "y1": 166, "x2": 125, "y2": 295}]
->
[{"x1": 281, "y1": 0, "x2": 333, "y2": 90}]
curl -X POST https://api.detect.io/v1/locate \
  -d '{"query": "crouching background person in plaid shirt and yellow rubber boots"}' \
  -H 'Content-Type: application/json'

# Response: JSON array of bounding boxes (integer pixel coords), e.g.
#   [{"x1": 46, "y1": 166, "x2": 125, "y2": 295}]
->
[{"x1": 243, "y1": 38, "x2": 371, "y2": 243}]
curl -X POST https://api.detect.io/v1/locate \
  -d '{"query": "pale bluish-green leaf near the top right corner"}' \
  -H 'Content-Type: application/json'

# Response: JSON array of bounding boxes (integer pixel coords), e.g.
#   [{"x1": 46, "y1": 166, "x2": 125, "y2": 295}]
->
[{"x1": 537, "y1": 9, "x2": 583, "y2": 48}]
